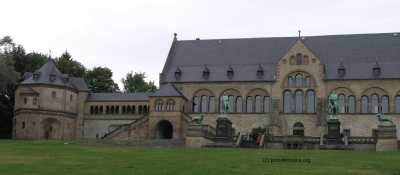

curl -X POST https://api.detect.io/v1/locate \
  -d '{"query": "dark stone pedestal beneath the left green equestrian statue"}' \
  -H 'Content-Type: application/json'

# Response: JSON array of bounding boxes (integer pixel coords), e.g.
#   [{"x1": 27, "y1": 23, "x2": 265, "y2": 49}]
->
[{"x1": 202, "y1": 117, "x2": 235, "y2": 148}]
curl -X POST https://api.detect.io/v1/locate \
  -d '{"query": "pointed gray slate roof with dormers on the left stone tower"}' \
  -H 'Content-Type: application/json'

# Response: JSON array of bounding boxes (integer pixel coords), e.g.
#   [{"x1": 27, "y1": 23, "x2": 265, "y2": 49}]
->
[{"x1": 20, "y1": 61, "x2": 89, "y2": 91}]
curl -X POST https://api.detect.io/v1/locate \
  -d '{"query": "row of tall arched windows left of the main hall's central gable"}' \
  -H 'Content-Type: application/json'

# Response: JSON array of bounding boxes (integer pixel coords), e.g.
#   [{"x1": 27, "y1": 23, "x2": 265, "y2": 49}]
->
[{"x1": 193, "y1": 95, "x2": 270, "y2": 113}]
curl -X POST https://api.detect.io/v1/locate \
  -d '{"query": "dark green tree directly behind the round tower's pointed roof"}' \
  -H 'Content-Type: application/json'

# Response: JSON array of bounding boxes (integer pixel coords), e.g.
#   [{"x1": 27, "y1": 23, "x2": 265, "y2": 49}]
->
[{"x1": 53, "y1": 51, "x2": 86, "y2": 77}]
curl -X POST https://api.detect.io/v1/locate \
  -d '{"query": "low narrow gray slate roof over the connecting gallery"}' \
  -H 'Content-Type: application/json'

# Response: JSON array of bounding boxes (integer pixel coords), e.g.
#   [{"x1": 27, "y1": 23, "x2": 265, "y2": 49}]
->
[{"x1": 86, "y1": 92, "x2": 152, "y2": 102}]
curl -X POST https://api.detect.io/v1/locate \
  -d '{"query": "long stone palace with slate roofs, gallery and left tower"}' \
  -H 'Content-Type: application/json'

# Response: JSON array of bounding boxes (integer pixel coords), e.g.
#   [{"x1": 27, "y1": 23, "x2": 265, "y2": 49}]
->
[{"x1": 13, "y1": 33, "x2": 400, "y2": 140}]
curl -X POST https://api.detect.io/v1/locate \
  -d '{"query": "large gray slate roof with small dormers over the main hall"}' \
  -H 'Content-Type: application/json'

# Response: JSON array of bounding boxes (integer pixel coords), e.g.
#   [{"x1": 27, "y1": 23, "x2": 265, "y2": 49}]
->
[{"x1": 161, "y1": 33, "x2": 400, "y2": 83}]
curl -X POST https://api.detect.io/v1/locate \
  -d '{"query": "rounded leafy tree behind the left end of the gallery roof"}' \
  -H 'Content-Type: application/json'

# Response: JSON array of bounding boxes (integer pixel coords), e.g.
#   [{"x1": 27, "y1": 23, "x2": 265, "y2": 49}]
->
[{"x1": 85, "y1": 67, "x2": 119, "y2": 93}]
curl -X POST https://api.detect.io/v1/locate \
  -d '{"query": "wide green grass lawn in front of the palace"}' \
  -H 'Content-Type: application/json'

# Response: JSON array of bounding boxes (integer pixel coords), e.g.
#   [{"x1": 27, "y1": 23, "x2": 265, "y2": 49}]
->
[{"x1": 0, "y1": 140, "x2": 400, "y2": 175}]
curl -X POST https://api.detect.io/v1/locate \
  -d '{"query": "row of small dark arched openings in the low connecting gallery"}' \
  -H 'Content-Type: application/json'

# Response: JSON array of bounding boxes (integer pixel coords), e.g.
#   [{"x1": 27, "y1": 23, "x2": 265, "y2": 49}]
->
[{"x1": 90, "y1": 105, "x2": 150, "y2": 114}]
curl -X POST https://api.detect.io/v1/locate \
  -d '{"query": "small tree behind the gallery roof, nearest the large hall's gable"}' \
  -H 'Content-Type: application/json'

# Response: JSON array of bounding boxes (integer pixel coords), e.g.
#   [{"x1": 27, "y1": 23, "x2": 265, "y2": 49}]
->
[{"x1": 121, "y1": 71, "x2": 157, "y2": 92}]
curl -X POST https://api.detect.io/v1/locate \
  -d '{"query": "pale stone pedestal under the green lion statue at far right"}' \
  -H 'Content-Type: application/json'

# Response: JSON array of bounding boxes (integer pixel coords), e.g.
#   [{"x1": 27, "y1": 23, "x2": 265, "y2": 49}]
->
[{"x1": 376, "y1": 125, "x2": 399, "y2": 151}]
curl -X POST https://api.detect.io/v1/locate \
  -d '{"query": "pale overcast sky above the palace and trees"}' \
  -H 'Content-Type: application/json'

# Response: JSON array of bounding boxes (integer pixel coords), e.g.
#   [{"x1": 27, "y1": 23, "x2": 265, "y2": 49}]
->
[{"x1": 0, "y1": 0, "x2": 400, "y2": 90}]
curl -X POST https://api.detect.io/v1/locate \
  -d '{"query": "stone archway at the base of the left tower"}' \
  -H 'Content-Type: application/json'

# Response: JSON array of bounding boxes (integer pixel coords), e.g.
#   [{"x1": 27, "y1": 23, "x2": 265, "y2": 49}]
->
[{"x1": 40, "y1": 118, "x2": 62, "y2": 140}]
